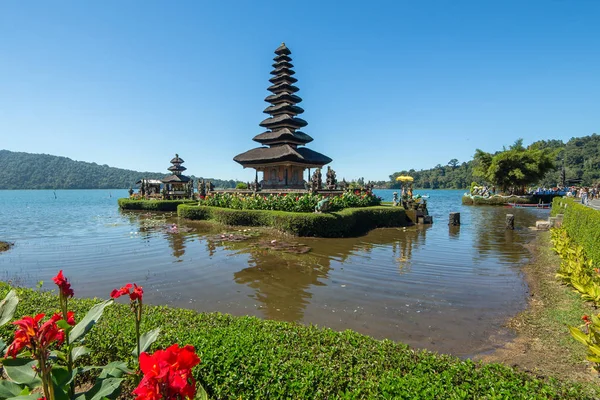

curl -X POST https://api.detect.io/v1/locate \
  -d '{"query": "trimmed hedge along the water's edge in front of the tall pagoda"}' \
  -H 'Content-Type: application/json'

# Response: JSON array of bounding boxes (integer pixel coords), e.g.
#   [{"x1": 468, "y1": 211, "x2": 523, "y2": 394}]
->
[{"x1": 177, "y1": 204, "x2": 410, "y2": 237}]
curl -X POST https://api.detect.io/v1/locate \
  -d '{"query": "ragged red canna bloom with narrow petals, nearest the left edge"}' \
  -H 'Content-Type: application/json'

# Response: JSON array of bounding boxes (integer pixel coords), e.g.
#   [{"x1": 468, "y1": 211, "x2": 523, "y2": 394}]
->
[{"x1": 6, "y1": 314, "x2": 65, "y2": 358}]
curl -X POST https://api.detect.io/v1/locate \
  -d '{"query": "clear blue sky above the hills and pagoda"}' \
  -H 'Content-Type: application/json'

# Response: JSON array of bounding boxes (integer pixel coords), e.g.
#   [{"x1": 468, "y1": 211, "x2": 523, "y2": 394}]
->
[{"x1": 0, "y1": 0, "x2": 600, "y2": 181}]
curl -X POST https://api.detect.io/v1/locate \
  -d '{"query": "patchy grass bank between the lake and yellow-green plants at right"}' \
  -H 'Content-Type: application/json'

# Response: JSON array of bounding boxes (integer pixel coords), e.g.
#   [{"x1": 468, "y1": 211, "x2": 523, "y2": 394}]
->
[{"x1": 483, "y1": 232, "x2": 600, "y2": 398}]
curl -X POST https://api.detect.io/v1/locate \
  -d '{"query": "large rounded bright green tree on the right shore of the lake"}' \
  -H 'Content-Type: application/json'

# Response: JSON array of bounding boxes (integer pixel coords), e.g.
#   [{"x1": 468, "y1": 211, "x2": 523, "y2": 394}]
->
[{"x1": 473, "y1": 139, "x2": 556, "y2": 193}]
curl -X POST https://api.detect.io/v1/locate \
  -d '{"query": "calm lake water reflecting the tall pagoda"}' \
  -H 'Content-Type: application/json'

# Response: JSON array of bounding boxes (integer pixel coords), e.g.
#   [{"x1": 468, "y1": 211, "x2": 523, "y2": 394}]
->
[{"x1": 0, "y1": 190, "x2": 548, "y2": 356}]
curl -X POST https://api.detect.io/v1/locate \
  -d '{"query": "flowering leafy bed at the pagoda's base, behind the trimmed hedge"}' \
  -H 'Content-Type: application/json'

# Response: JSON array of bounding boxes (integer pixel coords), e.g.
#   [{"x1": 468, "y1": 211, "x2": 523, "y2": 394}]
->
[{"x1": 200, "y1": 189, "x2": 381, "y2": 213}]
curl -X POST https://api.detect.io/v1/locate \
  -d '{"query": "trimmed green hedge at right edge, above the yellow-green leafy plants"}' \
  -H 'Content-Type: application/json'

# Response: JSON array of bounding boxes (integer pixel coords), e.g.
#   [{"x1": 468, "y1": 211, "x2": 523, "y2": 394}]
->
[{"x1": 552, "y1": 197, "x2": 600, "y2": 265}]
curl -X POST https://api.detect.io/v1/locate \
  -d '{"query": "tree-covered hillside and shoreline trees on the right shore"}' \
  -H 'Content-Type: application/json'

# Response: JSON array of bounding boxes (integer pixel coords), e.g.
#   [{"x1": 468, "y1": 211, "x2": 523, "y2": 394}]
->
[{"x1": 387, "y1": 133, "x2": 600, "y2": 191}]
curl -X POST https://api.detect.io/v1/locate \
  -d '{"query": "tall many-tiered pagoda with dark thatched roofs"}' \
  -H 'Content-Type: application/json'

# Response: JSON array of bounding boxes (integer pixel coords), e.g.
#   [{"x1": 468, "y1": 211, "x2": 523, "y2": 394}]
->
[{"x1": 233, "y1": 43, "x2": 331, "y2": 189}]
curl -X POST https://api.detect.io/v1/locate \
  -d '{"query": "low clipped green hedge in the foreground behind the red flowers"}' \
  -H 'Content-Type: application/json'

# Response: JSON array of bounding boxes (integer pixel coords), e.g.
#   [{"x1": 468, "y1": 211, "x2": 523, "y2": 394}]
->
[{"x1": 0, "y1": 283, "x2": 592, "y2": 399}]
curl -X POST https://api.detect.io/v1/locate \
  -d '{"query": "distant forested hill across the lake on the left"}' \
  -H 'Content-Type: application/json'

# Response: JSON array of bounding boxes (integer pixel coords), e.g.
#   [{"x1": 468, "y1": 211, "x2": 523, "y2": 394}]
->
[{"x1": 0, "y1": 150, "x2": 236, "y2": 190}]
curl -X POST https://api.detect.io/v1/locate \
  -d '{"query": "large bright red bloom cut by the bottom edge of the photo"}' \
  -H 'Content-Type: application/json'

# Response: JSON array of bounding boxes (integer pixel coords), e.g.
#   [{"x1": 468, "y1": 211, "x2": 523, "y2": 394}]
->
[{"x1": 133, "y1": 344, "x2": 200, "y2": 400}]
